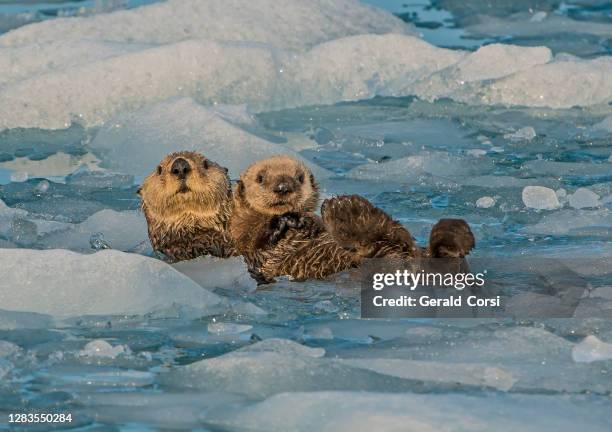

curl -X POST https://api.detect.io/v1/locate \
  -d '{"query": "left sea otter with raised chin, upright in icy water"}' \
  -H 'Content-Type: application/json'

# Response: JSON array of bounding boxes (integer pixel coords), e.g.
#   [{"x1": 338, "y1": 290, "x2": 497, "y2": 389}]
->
[{"x1": 138, "y1": 151, "x2": 236, "y2": 262}]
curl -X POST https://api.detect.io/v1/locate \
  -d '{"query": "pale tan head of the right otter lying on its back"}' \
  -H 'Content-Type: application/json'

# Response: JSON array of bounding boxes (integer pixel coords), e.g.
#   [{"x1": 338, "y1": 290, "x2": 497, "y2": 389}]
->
[{"x1": 235, "y1": 156, "x2": 319, "y2": 215}]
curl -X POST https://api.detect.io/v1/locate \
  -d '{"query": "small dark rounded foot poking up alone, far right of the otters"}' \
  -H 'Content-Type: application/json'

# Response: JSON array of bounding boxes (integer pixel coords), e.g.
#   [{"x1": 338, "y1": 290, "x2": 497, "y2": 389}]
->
[{"x1": 429, "y1": 219, "x2": 476, "y2": 258}]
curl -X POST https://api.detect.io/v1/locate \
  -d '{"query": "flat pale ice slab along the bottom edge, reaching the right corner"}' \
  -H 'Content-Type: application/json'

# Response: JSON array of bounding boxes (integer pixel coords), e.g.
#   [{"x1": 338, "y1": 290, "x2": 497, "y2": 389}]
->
[{"x1": 204, "y1": 391, "x2": 609, "y2": 432}]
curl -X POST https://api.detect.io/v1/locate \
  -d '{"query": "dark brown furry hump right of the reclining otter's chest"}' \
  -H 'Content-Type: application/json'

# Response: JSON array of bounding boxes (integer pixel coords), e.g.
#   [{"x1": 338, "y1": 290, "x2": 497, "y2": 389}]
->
[{"x1": 321, "y1": 195, "x2": 416, "y2": 258}]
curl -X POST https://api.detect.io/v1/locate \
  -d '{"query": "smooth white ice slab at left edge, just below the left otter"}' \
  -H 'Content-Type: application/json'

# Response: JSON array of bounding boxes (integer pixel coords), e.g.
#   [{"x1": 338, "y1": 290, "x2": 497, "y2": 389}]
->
[{"x1": 0, "y1": 249, "x2": 221, "y2": 316}]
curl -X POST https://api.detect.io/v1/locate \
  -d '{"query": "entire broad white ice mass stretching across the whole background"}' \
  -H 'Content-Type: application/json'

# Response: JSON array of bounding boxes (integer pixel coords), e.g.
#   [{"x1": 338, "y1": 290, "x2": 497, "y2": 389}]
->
[{"x1": 0, "y1": 0, "x2": 612, "y2": 132}]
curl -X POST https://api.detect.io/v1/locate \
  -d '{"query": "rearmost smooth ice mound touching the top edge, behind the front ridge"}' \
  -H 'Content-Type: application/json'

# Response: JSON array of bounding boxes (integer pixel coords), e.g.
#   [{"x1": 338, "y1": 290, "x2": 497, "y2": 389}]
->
[{"x1": 0, "y1": 0, "x2": 412, "y2": 49}]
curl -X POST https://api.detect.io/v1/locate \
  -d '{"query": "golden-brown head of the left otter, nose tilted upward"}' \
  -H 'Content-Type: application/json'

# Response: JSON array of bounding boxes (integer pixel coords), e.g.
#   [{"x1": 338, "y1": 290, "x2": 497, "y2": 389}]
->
[{"x1": 138, "y1": 151, "x2": 230, "y2": 223}]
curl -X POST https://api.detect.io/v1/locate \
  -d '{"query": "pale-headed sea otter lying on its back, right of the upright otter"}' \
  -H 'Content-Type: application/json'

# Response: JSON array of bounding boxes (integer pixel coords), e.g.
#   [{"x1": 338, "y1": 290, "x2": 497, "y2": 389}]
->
[{"x1": 230, "y1": 156, "x2": 418, "y2": 283}]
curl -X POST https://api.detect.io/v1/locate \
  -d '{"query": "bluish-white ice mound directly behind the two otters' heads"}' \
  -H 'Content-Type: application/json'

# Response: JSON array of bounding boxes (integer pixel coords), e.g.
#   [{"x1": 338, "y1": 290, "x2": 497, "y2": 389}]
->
[{"x1": 91, "y1": 98, "x2": 327, "y2": 177}]
